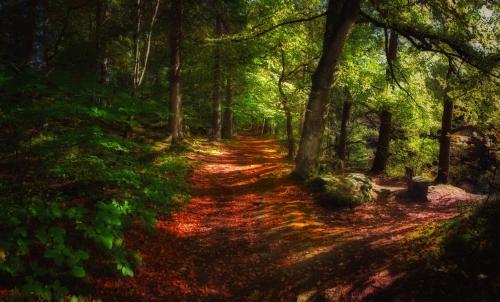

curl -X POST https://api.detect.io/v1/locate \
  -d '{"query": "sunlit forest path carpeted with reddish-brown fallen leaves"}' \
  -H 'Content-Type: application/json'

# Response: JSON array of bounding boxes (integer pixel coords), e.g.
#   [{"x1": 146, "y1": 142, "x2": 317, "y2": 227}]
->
[{"x1": 95, "y1": 137, "x2": 476, "y2": 301}]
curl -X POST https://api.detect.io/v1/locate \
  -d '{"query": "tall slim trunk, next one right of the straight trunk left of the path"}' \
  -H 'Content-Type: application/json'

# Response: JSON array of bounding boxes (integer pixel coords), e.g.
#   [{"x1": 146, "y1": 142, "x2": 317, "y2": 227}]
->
[{"x1": 211, "y1": 14, "x2": 222, "y2": 140}]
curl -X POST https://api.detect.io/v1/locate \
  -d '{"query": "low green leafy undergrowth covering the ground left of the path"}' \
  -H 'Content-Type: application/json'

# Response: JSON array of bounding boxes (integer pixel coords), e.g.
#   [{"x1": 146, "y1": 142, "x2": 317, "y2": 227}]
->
[{"x1": 0, "y1": 74, "x2": 187, "y2": 300}]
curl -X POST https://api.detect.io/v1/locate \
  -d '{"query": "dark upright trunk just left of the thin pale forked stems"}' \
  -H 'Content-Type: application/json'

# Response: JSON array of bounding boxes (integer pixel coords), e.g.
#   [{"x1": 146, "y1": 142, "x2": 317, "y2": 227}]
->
[{"x1": 96, "y1": 0, "x2": 109, "y2": 85}]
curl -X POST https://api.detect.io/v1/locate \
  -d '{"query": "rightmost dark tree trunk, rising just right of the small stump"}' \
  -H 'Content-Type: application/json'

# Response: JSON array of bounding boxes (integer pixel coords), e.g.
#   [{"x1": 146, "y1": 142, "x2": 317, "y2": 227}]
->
[{"x1": 436, "y1": 93, "x2": 453, "y2": 184}]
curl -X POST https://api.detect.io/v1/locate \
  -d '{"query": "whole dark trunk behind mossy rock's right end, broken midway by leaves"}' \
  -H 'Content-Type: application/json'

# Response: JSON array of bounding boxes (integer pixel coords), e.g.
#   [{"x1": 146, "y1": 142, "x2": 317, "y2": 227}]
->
[{"x1": 371, "y1": 31, "x2": 399, "y2": 174}]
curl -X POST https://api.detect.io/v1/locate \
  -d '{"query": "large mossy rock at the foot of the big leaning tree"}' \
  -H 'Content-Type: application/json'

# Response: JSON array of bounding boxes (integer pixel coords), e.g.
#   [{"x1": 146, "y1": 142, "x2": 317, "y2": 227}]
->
[{"x1": 307, "y1": 173, "x2": 375, "y2": 208}]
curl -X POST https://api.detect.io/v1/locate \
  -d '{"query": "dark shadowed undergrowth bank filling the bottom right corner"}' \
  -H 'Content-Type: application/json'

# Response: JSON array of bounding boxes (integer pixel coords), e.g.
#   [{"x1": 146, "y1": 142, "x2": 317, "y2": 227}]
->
[{"x1": 374, "y1": 198, "x2": 500, "y2": 301}]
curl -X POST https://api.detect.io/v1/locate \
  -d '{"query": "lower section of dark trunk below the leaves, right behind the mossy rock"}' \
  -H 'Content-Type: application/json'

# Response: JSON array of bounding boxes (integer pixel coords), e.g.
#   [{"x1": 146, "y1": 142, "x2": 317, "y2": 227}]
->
[{"x1": 371, "y1": 110, "x2": 392, "y2": 174}]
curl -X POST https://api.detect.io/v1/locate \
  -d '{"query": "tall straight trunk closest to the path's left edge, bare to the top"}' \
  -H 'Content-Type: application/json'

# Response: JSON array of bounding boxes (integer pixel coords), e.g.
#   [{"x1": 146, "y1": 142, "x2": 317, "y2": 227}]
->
[{"x1": 168, "y1": 0, "x2": 182, "y2": 145}]
